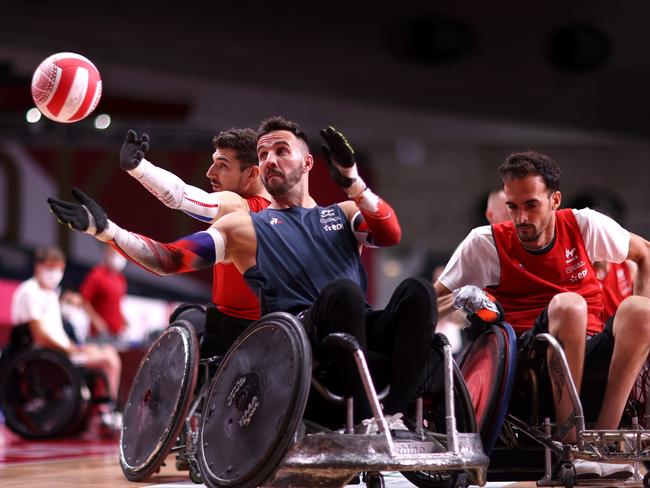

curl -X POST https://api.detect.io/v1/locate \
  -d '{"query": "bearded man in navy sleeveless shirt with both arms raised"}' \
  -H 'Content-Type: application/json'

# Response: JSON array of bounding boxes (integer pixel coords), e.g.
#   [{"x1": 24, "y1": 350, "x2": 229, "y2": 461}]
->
[{"x1": 48, "y1": 117, "x2": 437, "y2": 428}]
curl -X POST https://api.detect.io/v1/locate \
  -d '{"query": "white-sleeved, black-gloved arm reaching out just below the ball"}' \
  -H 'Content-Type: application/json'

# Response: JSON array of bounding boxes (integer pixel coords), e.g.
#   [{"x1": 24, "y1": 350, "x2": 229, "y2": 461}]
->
[{"x1": 120, "y1": 129, "x2": 248, "y2": 222}]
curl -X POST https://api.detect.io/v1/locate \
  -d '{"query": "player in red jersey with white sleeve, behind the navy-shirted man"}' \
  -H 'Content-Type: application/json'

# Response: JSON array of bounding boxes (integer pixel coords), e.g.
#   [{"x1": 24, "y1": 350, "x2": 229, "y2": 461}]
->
[{"x1": 120, "y1": 128, "x2": 271, "y2": 355}]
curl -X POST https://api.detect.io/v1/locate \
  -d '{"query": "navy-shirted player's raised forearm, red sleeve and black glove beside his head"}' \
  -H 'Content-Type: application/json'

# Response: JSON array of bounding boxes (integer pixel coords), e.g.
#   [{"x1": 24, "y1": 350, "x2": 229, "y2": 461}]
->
[{"x1": 320, "y1": 127, "x2": 402, "y2": 247}]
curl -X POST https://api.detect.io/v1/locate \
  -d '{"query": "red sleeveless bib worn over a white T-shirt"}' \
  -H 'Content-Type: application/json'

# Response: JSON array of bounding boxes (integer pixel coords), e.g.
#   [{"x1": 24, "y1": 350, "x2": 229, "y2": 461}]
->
[{"x1": 488, "y1": 209, "x2": 604, "y2": 335}]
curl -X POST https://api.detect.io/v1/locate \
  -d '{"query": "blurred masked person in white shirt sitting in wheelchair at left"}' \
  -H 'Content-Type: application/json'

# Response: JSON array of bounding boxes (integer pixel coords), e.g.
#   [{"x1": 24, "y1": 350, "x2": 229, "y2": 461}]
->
[{"x1": 11, "y1": 247, "x2": 122, "y2": 429}]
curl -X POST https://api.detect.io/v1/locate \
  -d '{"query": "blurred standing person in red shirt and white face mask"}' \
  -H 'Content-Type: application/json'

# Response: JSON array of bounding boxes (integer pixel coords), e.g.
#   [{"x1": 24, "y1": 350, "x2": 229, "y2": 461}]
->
[{"x1": 79, "y1": 245, "x2": 127, "y2": 342}]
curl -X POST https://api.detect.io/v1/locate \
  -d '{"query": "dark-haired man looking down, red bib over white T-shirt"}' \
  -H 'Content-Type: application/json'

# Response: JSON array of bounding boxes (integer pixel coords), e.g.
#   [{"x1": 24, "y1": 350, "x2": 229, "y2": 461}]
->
[{"x1": 435, "y1": 152, "x2": 650, "y2": 477}]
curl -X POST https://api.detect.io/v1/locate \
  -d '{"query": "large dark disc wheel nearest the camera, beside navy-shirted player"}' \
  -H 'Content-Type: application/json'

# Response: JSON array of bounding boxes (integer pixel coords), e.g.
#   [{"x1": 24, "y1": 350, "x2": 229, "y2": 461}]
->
[{"x1": 198, "y1": 312, "x2": 311, "y2": 488}]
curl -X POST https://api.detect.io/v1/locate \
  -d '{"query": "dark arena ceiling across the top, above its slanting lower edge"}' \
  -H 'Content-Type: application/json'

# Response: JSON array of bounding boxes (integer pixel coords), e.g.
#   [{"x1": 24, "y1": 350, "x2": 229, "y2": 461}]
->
[{"x1": 0, "y1": 0, "x2": 650, "y2": 138}]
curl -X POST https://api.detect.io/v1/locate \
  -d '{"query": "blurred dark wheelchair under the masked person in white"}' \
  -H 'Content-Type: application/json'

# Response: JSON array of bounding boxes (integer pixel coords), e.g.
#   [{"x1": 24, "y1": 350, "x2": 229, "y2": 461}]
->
[{"x1": 0, "y1": 324, "x2": 110, "y2": 439}]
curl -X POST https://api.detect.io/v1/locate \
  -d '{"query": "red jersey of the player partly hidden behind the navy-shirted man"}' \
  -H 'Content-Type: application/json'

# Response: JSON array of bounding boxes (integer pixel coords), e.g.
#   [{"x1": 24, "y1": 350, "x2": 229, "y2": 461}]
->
[{"x1": 212, "y1": 196, "x2": 271, "y2": 320}]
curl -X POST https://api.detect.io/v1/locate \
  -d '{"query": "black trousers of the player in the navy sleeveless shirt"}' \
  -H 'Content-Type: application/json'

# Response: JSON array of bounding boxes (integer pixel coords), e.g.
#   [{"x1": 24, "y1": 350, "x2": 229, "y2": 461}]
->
[{"x1": 309, "y1": 278, "x2": 438, "y2": 422}]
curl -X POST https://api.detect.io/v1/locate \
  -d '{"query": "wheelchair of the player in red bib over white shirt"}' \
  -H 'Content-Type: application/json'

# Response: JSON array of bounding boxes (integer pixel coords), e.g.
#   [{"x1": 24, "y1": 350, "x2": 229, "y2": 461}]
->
[{"x1": 460, "y1": 322, "x2": 650, "y2": 488}]
